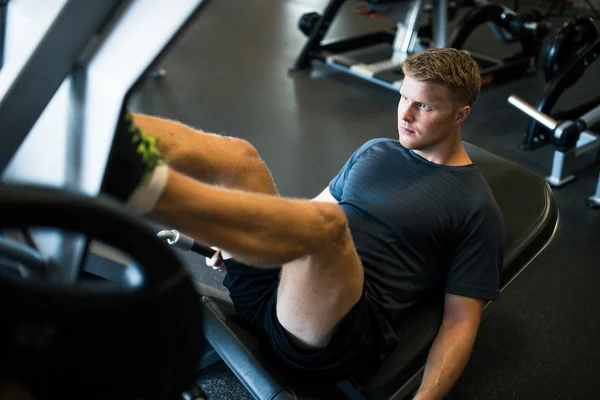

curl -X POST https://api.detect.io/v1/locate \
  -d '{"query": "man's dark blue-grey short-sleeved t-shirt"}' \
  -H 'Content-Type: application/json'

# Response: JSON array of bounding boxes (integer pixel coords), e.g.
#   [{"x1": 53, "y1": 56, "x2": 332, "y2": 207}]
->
[{"x1": 329, "y1": 139, "x2": 505, "y2": 346}]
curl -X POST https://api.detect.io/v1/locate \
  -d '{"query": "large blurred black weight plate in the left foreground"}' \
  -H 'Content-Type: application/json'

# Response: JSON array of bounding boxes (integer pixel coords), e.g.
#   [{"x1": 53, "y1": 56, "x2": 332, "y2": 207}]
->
[{"x1": 0, "y1": 184, "x2": 204, "y2": 399}]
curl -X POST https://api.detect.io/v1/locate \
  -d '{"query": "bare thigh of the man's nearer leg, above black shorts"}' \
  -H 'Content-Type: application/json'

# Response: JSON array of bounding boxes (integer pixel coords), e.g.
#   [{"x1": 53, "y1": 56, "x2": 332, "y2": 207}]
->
[{"x1": 277, "y1": 231, "x2": 364, "y2": 349}]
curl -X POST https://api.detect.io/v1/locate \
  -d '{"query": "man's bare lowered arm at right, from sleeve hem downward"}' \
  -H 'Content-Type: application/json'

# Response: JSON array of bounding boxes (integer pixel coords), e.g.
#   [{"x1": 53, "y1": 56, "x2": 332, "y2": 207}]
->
[{"x1": 414, "y1": 294, "x2": 484, "y2": 400}]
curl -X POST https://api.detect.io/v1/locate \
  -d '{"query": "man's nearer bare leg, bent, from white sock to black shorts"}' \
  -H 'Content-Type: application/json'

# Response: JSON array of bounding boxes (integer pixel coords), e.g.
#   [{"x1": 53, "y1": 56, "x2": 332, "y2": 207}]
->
[{"x1": 155, "y1": 170, "x2": 363, "y2": 347}]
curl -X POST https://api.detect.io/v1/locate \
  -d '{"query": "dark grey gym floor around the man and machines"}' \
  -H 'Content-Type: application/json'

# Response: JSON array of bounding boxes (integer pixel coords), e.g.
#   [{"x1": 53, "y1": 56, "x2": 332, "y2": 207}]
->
[{"x1": 134, "y1": 0, "x2": 600, "y2": 400}]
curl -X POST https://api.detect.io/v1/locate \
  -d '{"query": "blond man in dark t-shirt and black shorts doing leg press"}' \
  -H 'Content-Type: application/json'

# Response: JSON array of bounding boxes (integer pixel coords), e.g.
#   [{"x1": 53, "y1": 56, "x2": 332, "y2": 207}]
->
[{"x1": 104, "y1": 49, "x2": 504, "y2": 399}]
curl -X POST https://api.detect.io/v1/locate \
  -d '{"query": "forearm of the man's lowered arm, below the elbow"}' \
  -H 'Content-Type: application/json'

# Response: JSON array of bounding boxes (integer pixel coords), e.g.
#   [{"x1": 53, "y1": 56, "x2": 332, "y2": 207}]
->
[{"x1": 414, "y1": 323, "x2": 477, "y2": 400}]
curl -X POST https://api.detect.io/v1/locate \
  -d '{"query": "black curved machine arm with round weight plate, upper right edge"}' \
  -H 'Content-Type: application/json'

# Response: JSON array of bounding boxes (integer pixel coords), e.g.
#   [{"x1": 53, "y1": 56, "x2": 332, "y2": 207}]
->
[{"x1": 520, "y1": 18, "x2": 600, "y2": 150}]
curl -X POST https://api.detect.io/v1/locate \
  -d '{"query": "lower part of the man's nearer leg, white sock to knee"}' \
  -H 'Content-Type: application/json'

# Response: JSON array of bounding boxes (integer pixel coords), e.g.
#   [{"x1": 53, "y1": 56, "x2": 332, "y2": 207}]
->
[{"x1": 153, "y1": 170, "x2": 341, "y2": 266}]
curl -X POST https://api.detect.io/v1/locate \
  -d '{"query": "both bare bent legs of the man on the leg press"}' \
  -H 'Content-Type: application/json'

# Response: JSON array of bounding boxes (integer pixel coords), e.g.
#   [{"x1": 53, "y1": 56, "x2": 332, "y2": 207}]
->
[{"x1": 135, "y1": 115, "x2": 363, "y2": 347}]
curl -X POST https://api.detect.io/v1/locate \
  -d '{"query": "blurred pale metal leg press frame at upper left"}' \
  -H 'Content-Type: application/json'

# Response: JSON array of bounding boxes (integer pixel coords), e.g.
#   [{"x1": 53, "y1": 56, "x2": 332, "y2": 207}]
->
[{"x1": 0, "y1": 0, "x2": 203, "y2": 282}]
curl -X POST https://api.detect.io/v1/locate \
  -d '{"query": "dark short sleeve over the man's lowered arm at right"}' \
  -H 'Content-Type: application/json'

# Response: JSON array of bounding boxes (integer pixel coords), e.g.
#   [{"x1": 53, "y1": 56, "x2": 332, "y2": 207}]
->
[{"x1": 445, "y1": 193, "x2": 505, "y2": 300}]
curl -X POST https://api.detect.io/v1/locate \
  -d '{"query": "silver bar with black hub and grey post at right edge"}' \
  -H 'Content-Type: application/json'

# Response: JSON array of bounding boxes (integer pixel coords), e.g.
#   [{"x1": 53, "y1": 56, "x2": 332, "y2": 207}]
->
[{"x1": 508, "y1": 95, "x2": 600, "y2": 208}]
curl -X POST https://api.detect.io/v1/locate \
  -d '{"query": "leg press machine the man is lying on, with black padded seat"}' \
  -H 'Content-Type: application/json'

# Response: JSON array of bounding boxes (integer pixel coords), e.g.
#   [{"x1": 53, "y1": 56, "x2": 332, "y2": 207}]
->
[{"x1": 0, "y1": 0, "x2": 559, "y2": 399}]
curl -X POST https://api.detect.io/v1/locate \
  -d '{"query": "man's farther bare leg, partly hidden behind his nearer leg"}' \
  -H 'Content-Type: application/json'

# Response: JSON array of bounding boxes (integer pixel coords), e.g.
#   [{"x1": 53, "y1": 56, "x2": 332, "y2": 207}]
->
[{"x1": 132, "y1": 114, "x2": 277, "y2": 194}]
